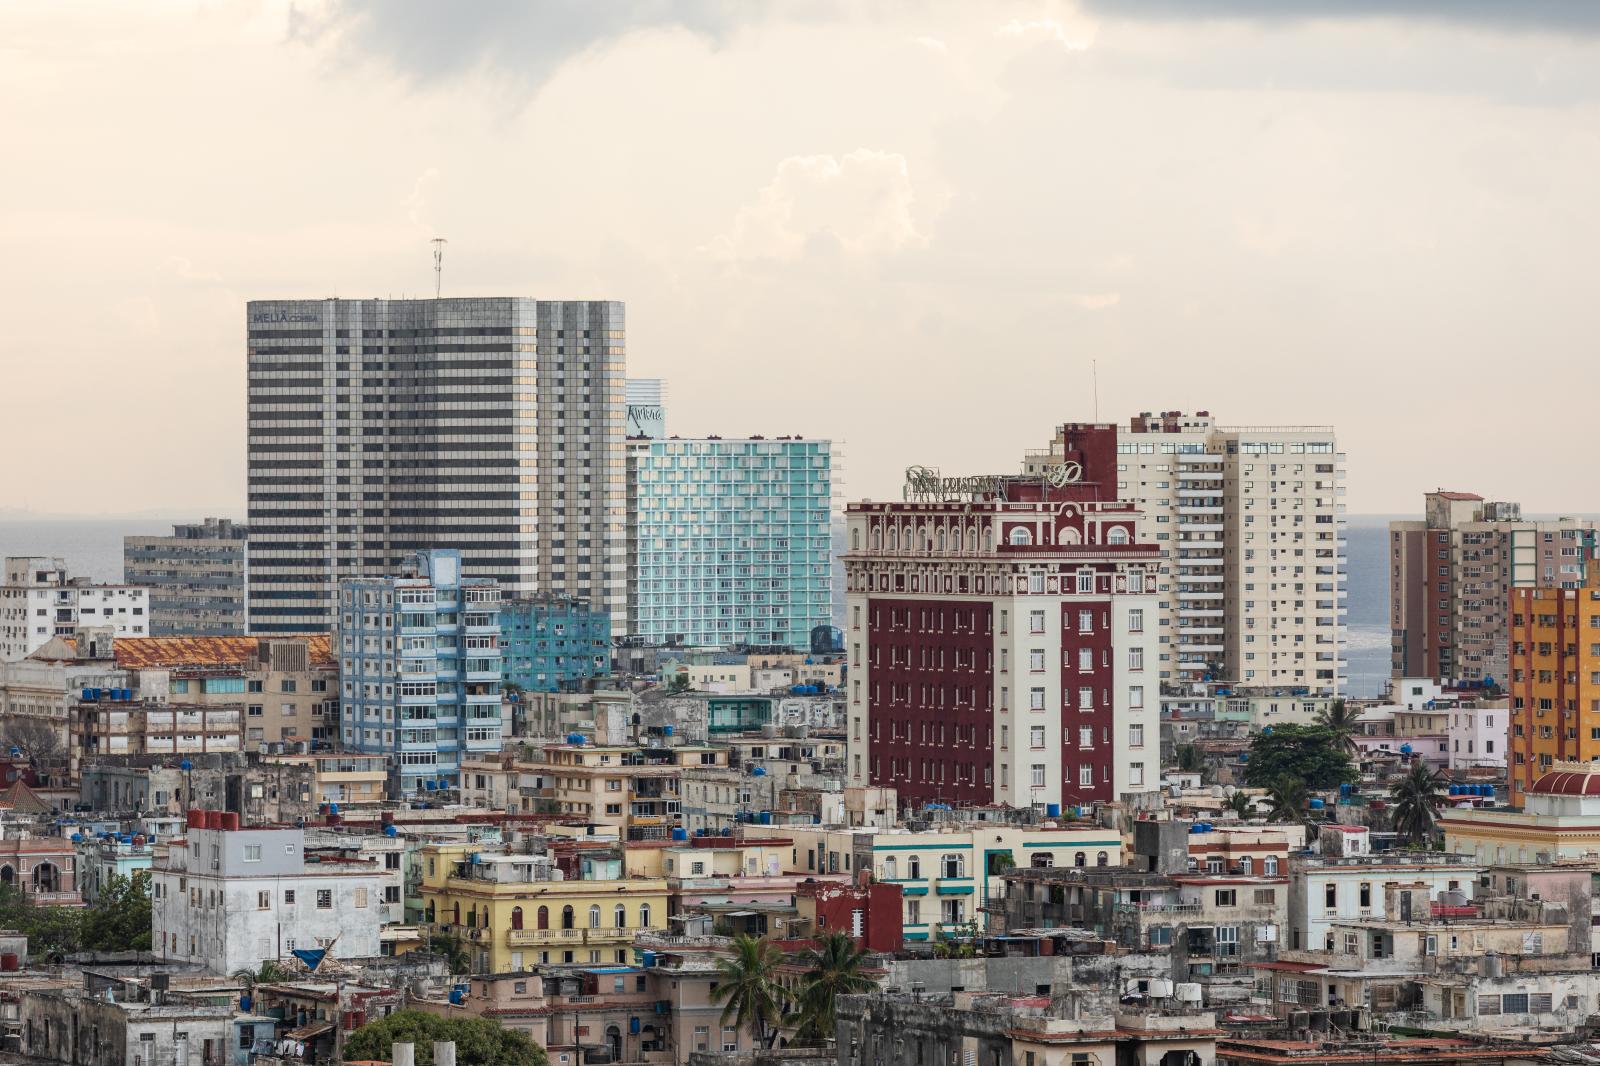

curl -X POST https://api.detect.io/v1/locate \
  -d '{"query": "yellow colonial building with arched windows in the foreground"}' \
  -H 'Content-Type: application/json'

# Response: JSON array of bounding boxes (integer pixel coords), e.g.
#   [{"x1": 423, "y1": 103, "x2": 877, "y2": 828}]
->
[{"x1": 419, "y1": 844, "x2": 667, "y2": 973}]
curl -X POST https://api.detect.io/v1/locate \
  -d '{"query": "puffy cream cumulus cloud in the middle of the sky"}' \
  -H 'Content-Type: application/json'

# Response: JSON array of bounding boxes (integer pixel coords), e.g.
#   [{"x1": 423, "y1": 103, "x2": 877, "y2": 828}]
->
[{"x1": 707, "y1": 149, "x2": 928, "y2": 261}]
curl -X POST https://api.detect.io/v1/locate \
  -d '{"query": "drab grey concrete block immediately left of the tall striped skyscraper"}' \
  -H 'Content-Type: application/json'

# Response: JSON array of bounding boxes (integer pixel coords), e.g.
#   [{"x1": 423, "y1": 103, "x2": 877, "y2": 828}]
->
[{"x1": 122, "y1": 519, "x2": 250, "y2": 637}]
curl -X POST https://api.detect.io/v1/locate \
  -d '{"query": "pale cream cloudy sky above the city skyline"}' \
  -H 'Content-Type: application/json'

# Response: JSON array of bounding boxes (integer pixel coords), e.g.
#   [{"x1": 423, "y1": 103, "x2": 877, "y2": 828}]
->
[{"x1": 0, "y1": 0, "x2": 1600, "y2": 517}]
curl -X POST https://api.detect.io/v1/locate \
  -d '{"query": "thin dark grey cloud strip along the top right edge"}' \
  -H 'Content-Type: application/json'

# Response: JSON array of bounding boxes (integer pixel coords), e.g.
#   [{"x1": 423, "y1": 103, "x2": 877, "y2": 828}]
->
[{"x1": 1083, "y1": 0, "x2": 1600, "y2": 34}]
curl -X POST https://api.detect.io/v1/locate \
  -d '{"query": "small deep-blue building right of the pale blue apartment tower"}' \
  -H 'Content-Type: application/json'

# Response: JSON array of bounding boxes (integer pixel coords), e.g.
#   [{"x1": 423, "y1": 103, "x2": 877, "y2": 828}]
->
[{"x1": 501, "y1": 595, "x2": 611, "y2": 691}]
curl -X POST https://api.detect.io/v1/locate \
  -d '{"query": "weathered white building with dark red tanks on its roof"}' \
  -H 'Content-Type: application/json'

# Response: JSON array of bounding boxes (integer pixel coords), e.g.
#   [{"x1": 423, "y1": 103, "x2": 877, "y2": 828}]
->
[{"x1": 150, "y1": 812, "x2": 386, "y2": 975}]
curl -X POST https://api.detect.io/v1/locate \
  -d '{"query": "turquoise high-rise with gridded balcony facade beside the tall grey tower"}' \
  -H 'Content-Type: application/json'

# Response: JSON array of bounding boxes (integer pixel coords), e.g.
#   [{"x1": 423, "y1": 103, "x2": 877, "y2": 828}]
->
[{"x1": 627, "y1": 437, "x2": 834, "y2": 648}]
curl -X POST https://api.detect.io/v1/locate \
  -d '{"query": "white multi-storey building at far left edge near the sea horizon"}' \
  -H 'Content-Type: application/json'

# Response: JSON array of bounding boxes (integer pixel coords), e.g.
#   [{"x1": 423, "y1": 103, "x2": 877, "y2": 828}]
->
[{"x1": 0, "y1": 555, "x2": 150, "y2": 663}]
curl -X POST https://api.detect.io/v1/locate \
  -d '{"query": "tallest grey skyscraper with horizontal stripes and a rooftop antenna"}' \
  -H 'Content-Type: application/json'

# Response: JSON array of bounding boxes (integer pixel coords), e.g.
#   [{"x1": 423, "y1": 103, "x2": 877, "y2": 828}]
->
[{"x1": 246, "y1": 298, "x2": 626, "y2": 632}]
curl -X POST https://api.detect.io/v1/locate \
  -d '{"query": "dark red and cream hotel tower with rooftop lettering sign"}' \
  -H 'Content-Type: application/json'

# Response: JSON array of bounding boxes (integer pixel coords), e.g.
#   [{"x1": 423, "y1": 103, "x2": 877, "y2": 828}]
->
[{"x1": 845, "y1": 424, "x2": 1162, "y2": 808}]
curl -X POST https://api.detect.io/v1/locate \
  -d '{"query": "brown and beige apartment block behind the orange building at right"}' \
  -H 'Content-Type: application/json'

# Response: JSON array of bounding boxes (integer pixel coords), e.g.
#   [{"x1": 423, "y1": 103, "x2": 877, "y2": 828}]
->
[{"x1": 1389, "y1": 490, "x2": 1595, "y2": 685}]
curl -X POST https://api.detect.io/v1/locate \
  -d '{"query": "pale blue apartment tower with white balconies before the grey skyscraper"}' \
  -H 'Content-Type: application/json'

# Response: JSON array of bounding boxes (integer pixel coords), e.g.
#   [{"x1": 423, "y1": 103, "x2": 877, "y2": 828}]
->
[{"x1": 338, "y1": 549, "x2": 501, "y2": 797}]
